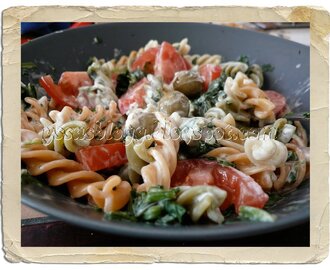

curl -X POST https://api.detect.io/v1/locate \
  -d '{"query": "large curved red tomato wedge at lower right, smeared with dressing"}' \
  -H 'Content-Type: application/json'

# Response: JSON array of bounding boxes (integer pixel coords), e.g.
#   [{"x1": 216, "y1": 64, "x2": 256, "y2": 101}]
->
[{"x1": 171, "y1": 159, "x2": 268, "y2": 213}]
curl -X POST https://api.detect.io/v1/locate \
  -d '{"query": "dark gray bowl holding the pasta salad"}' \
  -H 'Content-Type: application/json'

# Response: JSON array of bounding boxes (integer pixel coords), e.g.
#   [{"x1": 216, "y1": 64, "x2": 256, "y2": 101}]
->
[{"x1": 22, "y1": 23, "x2": 309, "y2": 241}]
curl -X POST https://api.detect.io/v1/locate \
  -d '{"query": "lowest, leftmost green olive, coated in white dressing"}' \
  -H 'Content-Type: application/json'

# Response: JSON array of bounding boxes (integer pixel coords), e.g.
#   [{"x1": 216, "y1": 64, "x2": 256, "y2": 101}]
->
[{"x1": 125, "y1": 110, "x2": 158, "y2": 139}]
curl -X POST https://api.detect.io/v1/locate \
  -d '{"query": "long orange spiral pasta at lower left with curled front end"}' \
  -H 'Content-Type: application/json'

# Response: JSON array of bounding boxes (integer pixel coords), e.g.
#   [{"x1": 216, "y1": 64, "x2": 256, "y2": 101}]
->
[{"x1": 21, "y1": 145, "x2": 131, "y2": 212}]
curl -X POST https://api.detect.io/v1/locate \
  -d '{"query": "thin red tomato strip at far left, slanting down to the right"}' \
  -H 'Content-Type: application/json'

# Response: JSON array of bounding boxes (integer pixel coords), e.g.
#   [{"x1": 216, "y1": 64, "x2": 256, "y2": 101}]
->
[{"x1": 39, "y1": 75, "x2": 78, "y2": 109}]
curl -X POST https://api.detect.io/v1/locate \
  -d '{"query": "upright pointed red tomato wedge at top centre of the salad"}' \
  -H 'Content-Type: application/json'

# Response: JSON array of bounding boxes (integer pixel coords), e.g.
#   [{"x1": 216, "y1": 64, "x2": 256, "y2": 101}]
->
[{"x1": 154, "y1": 42, "x2": 188, "y2": 83}]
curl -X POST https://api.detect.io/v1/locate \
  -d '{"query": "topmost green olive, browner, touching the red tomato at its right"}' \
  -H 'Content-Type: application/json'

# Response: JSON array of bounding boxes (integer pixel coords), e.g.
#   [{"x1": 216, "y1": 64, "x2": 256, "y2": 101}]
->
[{"x1": 172, "y1": 70, "x2": 203, "y2": 97}]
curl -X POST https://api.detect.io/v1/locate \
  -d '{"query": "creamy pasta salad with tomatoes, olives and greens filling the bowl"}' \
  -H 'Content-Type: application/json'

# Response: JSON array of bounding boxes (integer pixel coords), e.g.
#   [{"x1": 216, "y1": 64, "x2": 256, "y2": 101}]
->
[{"x1": 21, "y1": 38, "x2": 309, "y2": 225}]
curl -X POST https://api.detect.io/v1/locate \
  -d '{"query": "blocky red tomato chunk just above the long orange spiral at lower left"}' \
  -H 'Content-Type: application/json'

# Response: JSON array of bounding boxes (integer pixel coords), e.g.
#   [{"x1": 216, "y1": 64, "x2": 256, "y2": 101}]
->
[{"x1": 76, "y1": 143, "x2": 127, "y2": 171}]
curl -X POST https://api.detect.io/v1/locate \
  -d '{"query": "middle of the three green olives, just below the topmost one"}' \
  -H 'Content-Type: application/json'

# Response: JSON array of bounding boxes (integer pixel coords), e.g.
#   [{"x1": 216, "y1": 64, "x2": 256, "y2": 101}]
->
[{"x1": 158, "y1": 91, "x2": 190, "y2": 117}]
